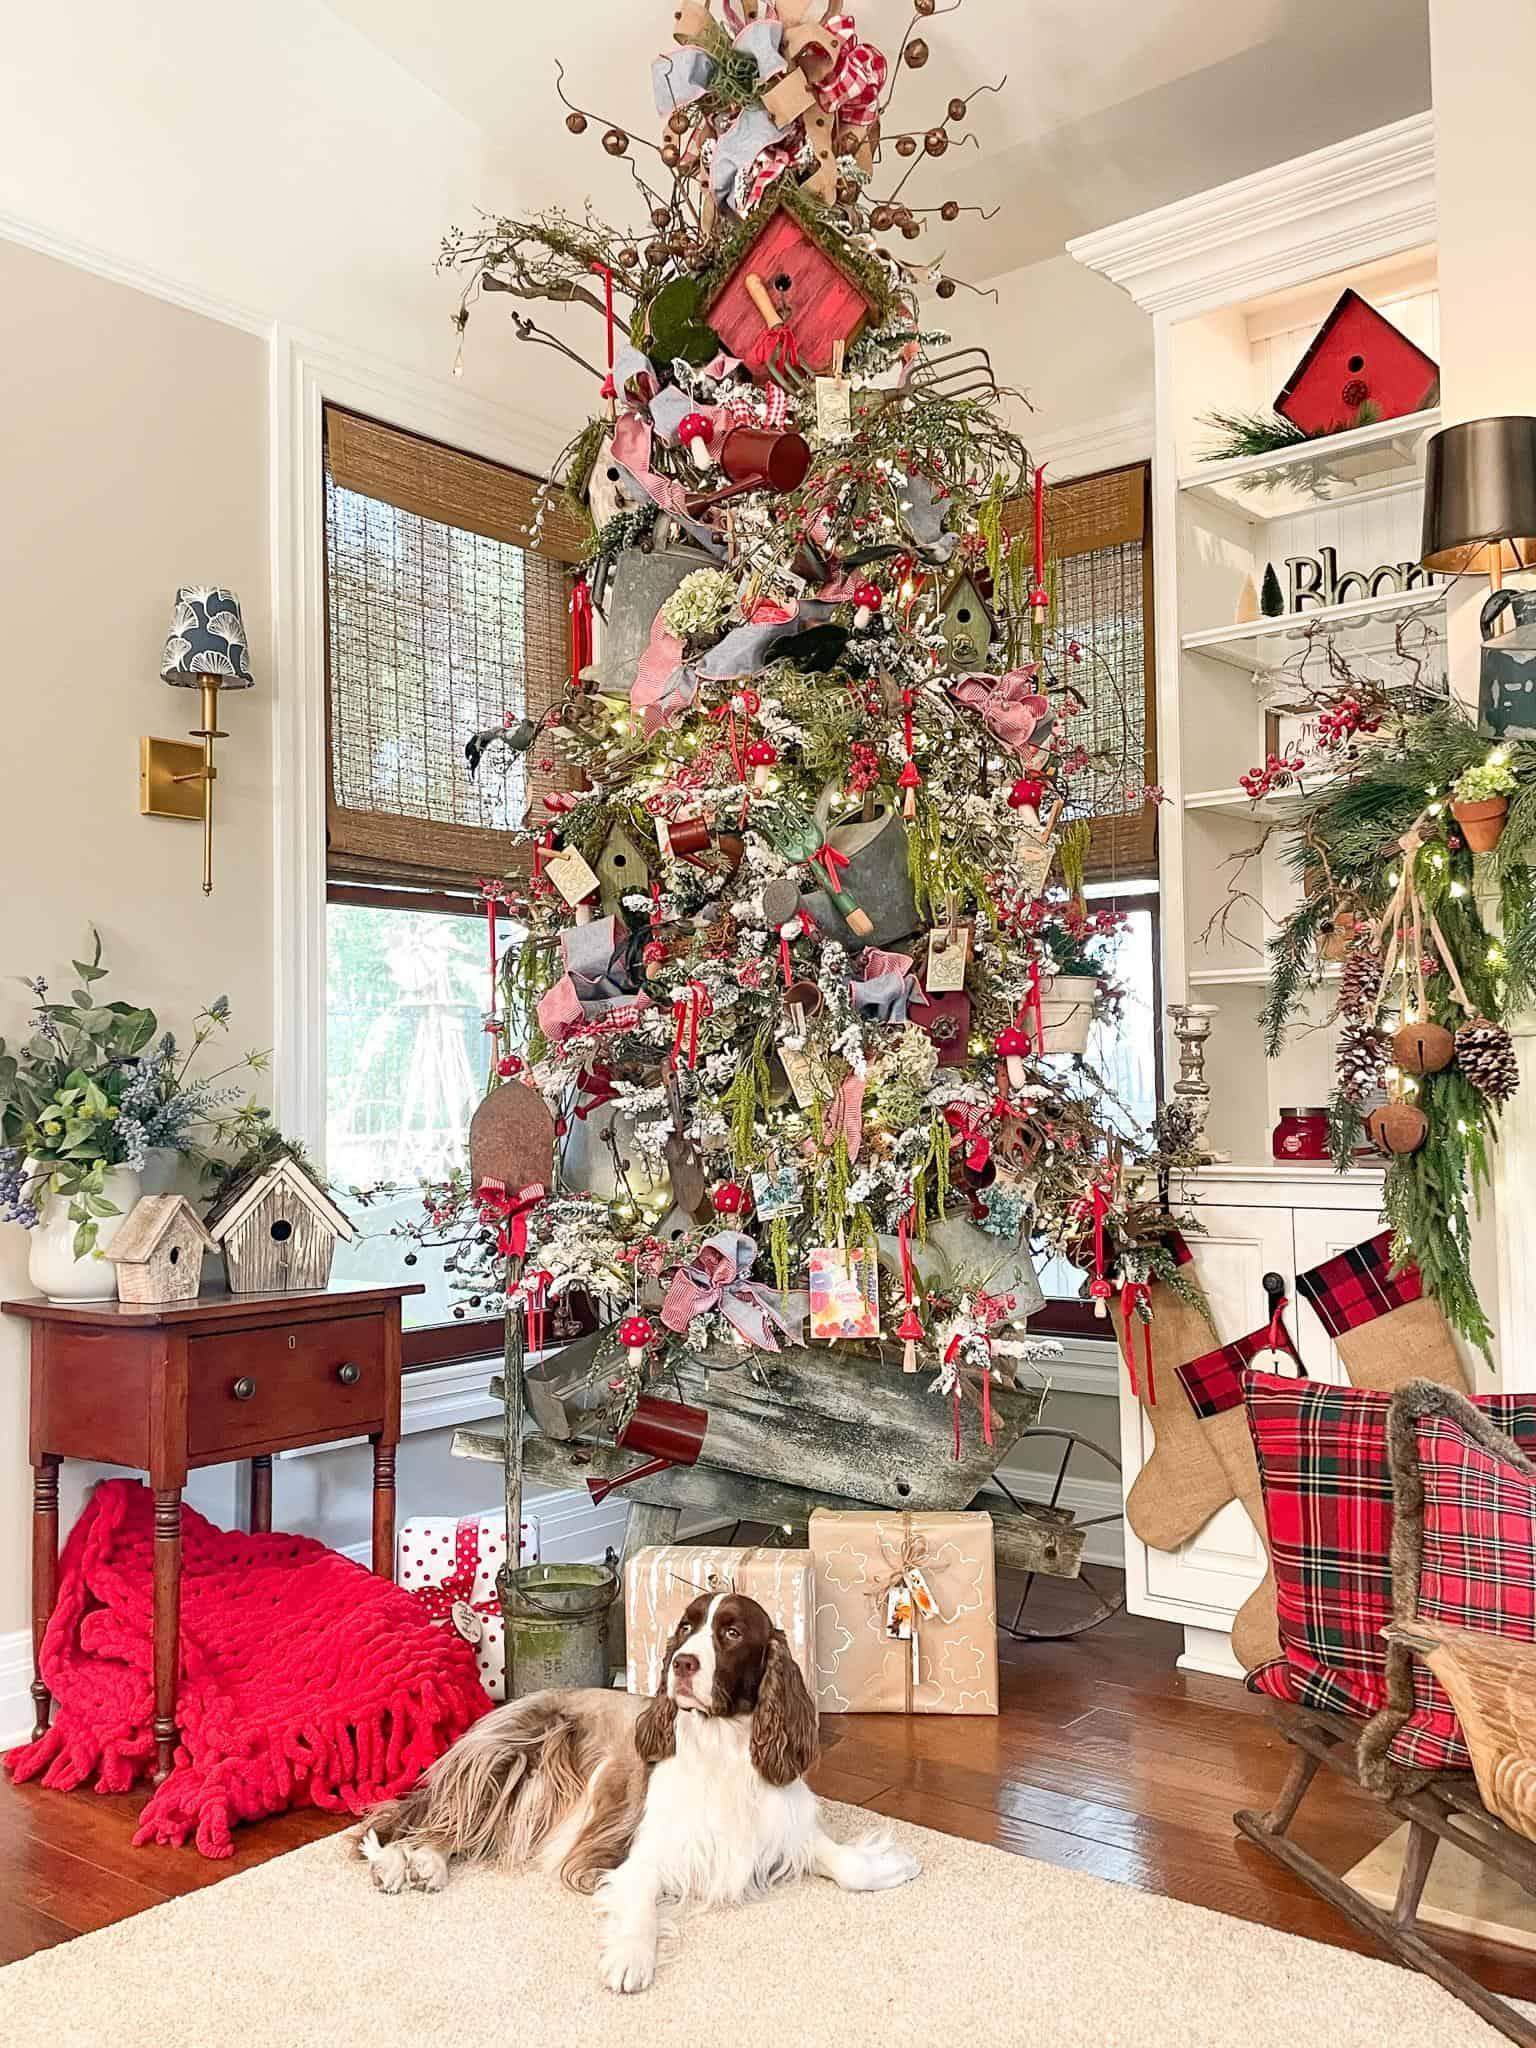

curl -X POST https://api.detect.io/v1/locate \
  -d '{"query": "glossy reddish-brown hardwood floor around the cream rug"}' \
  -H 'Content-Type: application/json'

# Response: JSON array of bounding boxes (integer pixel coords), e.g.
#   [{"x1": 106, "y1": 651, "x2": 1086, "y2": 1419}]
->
[{"x1": 0, "y1": 1573, "x2": 1532, "y2": 1997}]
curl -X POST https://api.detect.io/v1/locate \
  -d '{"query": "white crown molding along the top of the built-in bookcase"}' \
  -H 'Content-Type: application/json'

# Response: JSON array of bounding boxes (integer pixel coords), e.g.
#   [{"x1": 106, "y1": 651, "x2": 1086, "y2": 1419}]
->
[{"x1": 1067, "y1": 113, "x2": 1438, "y2": 313}]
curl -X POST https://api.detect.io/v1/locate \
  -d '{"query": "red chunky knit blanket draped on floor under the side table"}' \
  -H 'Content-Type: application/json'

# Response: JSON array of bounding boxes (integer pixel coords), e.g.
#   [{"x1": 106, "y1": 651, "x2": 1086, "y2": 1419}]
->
[{"x1": 6, "y1": 1479, "x2": 489, "y2": 1855}]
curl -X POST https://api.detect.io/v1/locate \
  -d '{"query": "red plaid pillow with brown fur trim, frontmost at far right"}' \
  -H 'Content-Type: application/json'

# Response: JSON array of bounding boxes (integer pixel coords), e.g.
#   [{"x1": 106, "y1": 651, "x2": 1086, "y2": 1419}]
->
[{"x1": 1382, "y1": 1401, "x2": 1536, "y2": 1772}]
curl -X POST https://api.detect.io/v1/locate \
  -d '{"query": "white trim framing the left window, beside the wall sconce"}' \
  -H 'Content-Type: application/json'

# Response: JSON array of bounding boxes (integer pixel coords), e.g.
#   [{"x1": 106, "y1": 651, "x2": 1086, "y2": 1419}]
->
[{"x1": 270, "y1": 328, "x2": 567, "y2": 1163}]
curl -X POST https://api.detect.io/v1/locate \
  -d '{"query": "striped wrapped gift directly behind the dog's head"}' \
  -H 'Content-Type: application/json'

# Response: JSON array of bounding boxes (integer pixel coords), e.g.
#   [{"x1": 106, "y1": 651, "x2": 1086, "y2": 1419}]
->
[{"x1": 625, "y1": 1544, "x2": 815, "y2": 1698}]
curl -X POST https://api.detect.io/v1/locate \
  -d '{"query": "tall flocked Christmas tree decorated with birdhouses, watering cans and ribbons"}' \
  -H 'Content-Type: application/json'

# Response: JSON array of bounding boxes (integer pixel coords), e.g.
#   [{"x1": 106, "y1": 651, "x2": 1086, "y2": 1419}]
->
[{"x1": 403, "y1": 0, "x2": 1192, "y2": 1483}]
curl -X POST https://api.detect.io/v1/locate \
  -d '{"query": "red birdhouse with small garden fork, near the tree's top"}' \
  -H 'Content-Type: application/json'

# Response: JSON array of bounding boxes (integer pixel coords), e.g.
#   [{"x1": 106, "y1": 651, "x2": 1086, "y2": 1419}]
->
[{"x1": 702, "y1": 199, "x2": 877, "y2": 371}]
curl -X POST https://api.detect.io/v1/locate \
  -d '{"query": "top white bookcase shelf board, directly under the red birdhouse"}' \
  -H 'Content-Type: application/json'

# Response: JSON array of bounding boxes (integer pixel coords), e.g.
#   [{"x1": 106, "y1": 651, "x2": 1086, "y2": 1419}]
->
[{"x1": 1180, "y1": 412, "x2": 1440, "y2": 524}]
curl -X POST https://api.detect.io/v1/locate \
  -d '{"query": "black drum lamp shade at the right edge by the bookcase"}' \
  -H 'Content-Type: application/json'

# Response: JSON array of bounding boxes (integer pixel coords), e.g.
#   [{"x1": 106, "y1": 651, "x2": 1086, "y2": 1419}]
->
[{"x1": 1423, "y1": 416, "x2": 1536, "y2": 575}]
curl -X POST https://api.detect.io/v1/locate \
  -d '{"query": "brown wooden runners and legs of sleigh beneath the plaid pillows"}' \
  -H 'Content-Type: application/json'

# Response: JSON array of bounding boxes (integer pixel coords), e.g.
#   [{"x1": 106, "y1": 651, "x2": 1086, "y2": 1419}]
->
[{"x1": 1233, "y1": 1702, "x2": 1536, "y2": 2048}]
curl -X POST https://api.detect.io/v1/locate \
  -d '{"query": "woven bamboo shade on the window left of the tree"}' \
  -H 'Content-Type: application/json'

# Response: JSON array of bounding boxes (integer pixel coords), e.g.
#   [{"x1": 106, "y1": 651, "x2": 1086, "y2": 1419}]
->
[{"x1": 326, "y1": 408, "x2": 575, "y2": 883}]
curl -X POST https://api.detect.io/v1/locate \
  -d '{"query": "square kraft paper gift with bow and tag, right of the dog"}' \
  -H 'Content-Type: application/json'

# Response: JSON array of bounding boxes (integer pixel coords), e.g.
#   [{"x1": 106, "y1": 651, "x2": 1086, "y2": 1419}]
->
[{"x1": 811, "y1": 1507, "x2": 997, "y2": 1714}]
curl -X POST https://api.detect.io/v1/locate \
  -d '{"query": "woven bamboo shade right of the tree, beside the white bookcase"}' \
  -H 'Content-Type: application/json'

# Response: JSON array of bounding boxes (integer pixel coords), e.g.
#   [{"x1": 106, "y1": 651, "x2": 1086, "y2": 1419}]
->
[{"x1": 1004, "y1": 463, "x2": 1157, "y2": 881}]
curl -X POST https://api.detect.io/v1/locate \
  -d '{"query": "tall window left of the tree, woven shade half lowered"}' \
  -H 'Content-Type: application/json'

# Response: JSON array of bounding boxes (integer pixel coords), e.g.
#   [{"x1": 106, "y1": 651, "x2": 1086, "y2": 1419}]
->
[{"x1": 326, "y1": 408, "x2": 580, "y2": 1364}]
